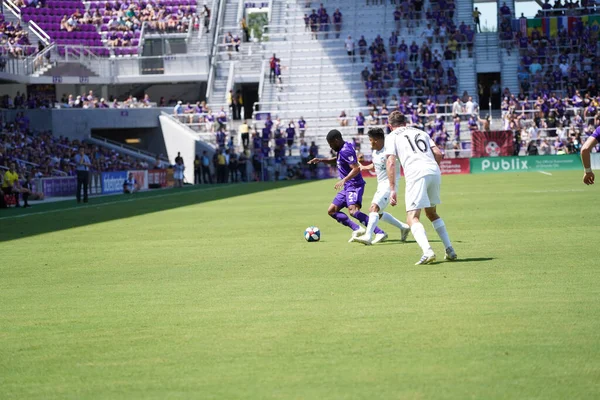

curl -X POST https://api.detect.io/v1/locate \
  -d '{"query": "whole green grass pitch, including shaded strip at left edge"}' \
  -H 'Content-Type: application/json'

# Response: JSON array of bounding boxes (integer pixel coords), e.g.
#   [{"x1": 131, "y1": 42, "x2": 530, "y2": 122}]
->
[{"x1": 0, "y1": 172, "x2": 600, "y2": 400}]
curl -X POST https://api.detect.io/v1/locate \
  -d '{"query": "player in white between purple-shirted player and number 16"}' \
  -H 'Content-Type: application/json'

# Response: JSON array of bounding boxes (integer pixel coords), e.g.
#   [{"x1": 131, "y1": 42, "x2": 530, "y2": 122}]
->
[{"x1": 352, "y1": 128, "x2": 410, "y2": 245}]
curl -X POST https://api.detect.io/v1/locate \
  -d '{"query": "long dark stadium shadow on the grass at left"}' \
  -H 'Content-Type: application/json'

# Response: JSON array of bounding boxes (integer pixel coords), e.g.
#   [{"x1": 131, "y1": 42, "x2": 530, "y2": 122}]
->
[{"x1": 0, "y1": 181, "x2": 313, "y2": 242}]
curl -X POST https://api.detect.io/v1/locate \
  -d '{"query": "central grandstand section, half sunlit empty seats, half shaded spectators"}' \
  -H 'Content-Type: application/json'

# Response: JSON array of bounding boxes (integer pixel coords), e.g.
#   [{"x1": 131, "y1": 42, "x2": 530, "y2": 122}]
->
[{"x1": 244, "y1": 1, "x2": 476, "y2": 158}]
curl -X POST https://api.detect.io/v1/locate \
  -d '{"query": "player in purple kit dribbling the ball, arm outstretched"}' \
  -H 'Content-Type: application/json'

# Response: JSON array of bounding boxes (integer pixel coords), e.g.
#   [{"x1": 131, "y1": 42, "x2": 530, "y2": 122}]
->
[{"x1": 308, "y1": 129, "x2": 387, "y2": 243}]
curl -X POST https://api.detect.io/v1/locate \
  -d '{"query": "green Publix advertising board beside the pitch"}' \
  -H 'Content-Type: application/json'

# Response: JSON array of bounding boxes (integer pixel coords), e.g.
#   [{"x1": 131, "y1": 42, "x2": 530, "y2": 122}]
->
[{"x1": 471, "y1": 154, "x2": 583, "y2": 174}]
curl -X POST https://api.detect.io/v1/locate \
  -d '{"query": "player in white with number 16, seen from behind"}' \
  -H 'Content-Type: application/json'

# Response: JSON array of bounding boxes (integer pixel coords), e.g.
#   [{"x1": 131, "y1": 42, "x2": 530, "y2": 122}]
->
[{"x1": 385, "y1": 111, "x2": 457, "y2": 265}]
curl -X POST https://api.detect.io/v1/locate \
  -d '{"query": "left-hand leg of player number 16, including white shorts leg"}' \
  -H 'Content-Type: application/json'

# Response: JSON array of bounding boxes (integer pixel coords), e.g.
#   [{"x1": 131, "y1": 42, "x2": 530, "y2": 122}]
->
[{"x1": 404, "y1": 177, "x2": 435, "y2": 265}]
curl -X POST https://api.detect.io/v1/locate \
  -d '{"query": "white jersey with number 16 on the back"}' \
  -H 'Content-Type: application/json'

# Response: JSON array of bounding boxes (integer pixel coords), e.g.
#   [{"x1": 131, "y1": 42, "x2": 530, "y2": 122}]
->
[{"x1": 385, "y1": 127, "x2": 441, "y2": 182}]
